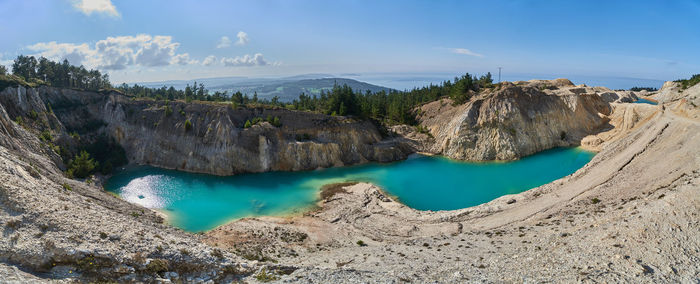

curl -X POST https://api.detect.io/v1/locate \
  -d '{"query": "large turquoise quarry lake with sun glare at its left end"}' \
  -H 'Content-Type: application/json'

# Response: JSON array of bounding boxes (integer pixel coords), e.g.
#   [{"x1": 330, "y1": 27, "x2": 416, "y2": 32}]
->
[{"x1": 106, "y1": 148, "x2": 594, "y2": 232}]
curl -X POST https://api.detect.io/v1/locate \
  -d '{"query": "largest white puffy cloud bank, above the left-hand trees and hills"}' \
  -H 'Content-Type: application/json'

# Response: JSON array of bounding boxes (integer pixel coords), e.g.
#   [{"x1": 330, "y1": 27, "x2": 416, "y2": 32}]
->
[{"x1": 27, "y1": 34, "x2": 191, "y2": 70}]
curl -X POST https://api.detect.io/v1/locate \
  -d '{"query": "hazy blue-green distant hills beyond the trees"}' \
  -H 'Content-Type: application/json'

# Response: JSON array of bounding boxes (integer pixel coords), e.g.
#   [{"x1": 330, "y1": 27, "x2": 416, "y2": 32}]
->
[{"x1": 137, "y1": 74, "x2": 392, "y2": 102}]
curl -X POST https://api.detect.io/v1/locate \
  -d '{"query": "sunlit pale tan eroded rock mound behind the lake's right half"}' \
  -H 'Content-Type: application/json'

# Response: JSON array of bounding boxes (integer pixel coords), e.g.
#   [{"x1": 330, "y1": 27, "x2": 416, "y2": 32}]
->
[{"x1": 418, "y1": 79, "x2": 612, "y2": 160}]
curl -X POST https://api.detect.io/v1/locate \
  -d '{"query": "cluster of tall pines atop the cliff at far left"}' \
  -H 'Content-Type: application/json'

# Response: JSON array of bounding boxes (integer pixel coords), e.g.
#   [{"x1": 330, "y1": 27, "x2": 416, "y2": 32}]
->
[{"x1": 7, "y1": 55, "x2": 112, "y2": 90}]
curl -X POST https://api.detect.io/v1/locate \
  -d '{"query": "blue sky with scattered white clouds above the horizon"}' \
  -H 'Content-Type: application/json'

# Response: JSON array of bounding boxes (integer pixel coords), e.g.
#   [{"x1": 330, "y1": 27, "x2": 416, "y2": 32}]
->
[{"x1": 0, "y1": 0, "x2": 700, "y2": 83}]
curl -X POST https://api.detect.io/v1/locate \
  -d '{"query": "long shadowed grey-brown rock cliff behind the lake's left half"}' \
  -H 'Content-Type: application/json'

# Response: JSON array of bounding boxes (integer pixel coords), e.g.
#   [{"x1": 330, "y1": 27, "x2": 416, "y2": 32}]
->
[{"x1": 0, "y1": 87, "x2": 413, "y2": 175}]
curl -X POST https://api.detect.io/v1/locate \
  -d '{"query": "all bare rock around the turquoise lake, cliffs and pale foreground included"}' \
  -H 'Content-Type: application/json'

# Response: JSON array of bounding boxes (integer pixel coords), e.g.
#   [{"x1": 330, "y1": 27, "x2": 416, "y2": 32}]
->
[{"x1": 0, "y1": 80, "x2": 700, "y2": 283}]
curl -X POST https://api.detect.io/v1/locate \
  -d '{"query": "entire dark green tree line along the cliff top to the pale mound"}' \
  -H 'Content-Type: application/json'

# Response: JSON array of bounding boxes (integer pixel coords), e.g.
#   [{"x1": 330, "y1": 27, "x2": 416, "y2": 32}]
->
[{"x1": 0, "y1": 55, "x2": 493, "y2": 124}]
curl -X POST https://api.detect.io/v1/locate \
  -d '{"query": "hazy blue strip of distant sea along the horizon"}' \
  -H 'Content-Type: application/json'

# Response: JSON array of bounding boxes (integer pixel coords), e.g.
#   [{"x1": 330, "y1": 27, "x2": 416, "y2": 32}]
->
[{"x1": 338, "y1": 72, "x2": 664, "y2": 90}]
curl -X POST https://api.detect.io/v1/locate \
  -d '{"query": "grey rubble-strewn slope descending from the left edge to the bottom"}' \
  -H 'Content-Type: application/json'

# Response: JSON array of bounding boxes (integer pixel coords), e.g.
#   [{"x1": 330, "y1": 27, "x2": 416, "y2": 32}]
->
[{"x1": 0, "y1": 86, "x2": 262, "y2": 283}]
